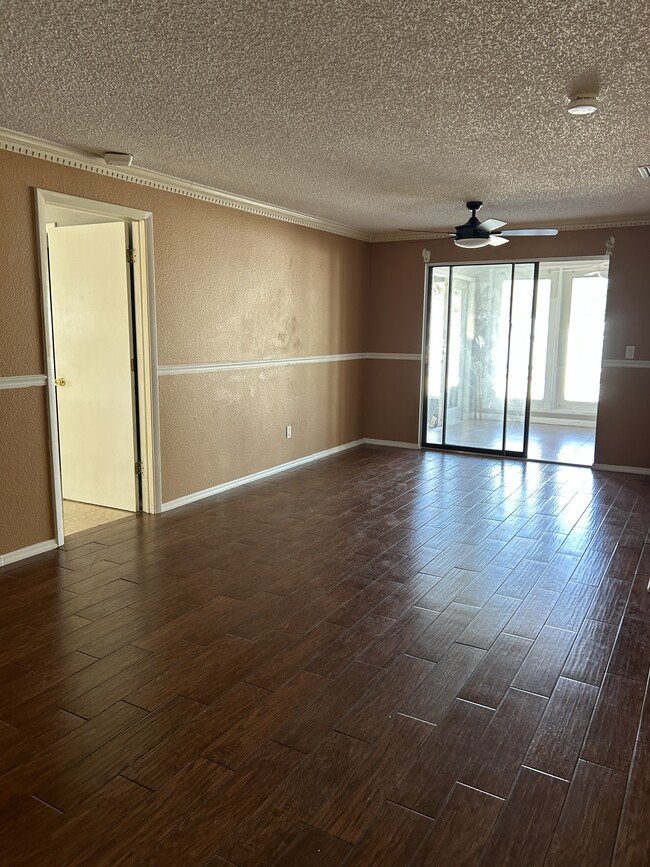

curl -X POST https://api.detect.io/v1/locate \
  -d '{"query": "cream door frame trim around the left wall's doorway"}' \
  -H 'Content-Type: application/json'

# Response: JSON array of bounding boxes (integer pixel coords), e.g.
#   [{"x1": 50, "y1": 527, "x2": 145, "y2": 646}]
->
[{"x1": 34, "y1": 189, "x2": 162, "y2": 546}]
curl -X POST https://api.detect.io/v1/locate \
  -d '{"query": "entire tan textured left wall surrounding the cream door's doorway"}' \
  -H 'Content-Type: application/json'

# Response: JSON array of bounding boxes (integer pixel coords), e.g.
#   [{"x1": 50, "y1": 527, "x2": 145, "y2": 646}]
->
[{"x1": 0, "y1": 152, "x2": 369, "y2": 552}]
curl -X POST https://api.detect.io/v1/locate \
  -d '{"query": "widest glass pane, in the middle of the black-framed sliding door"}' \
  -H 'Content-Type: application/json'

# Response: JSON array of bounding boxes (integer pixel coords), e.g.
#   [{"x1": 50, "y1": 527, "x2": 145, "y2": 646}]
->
[{"x1": 445, "y1": 264, "x2": 512, "y2": 450}]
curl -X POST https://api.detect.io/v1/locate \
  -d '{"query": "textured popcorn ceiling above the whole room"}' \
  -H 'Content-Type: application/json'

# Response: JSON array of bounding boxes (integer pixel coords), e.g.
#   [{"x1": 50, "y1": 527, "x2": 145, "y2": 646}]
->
[{"x1": 0, "y1": 0, "x2": 650, "y2": 231}]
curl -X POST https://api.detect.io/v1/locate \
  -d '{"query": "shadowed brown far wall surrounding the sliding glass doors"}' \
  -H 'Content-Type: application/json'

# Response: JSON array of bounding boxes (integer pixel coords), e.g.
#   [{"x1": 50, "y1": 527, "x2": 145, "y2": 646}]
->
[{"x1": 365, "y1": 226, "x2": 650, "y2": 467}]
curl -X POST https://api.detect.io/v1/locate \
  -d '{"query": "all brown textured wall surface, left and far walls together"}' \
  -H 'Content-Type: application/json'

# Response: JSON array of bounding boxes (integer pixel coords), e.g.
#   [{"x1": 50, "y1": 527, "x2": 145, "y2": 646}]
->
[{"x1": 0, "y1": 141, "x2": 650, "y2": 551}]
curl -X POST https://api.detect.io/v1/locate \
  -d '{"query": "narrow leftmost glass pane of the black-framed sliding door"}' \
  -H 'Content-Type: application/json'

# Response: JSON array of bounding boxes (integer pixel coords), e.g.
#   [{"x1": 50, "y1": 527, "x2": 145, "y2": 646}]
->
[{"x1": 425, "y1": 268, "x2": 449, "y2": 445}]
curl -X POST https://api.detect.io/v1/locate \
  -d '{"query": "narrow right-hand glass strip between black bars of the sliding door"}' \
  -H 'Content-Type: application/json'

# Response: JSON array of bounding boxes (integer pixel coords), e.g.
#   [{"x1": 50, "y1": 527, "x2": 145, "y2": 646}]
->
[{"x1": 506, "y1": 263, "x2": 535, "y2": 452}]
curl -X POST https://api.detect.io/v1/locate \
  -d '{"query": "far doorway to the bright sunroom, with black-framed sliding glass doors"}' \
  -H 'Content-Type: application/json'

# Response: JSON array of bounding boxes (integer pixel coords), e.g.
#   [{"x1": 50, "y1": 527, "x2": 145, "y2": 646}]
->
[{"x1": 422, "y1": 259, "x2": 608, "y2": 465}]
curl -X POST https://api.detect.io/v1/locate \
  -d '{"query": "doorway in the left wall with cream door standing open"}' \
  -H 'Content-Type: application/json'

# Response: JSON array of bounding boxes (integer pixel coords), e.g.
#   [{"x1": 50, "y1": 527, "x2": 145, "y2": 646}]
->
[{"x1": 37, "y1": 190, "x2": 161, "y2": 545}]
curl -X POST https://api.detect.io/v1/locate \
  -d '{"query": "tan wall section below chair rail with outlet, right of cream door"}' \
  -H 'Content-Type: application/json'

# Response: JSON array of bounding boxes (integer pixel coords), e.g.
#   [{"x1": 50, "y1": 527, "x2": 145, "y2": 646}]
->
[{"x1": 160, "y1": 361, "x2": 364, "y2": 501}]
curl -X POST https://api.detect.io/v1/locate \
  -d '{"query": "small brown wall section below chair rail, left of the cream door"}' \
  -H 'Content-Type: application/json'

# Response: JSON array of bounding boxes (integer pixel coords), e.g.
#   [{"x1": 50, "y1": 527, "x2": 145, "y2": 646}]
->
[{"x1": 0, "y1": 388, "x2": 54, "y2": 553}]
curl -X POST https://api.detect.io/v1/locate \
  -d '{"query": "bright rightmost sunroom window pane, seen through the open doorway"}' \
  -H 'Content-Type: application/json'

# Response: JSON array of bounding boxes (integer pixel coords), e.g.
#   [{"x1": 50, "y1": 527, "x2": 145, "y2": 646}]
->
[{"x1": 564, "y1": 275, "x2": 607, "y2": 403}]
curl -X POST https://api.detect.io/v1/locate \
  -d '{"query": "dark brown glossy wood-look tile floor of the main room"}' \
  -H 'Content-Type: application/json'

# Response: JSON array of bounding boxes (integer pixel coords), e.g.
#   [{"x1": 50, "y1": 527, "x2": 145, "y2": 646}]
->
[{"x1": 0, "y1": 447, "x2": 650, "y2": 867}]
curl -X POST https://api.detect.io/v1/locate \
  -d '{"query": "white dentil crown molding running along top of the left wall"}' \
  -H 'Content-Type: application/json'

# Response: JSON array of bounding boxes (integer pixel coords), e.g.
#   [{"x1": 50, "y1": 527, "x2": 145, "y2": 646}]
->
[{"x1": 0, "y1": 127, "x2": 370, "y2": 241}]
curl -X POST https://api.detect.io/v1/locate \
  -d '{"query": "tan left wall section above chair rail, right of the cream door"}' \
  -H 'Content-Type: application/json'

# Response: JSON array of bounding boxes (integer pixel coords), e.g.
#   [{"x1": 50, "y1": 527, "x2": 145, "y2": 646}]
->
[{"x1": 154, "y1": 196, "x2": 368, "y2": 364}]
